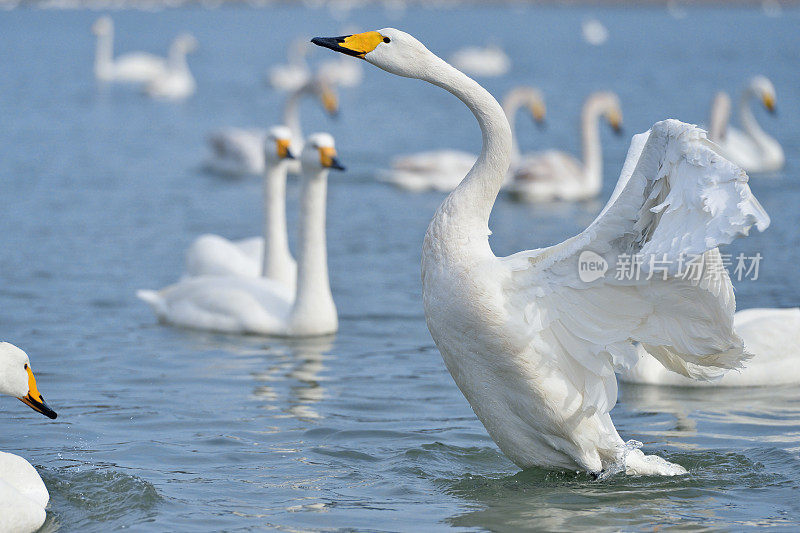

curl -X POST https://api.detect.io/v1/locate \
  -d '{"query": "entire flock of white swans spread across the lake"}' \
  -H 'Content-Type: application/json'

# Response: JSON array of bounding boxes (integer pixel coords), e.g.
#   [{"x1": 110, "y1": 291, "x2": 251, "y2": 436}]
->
[{"x1": 0, "y1": 17, "x2": 800, "y2": 531}]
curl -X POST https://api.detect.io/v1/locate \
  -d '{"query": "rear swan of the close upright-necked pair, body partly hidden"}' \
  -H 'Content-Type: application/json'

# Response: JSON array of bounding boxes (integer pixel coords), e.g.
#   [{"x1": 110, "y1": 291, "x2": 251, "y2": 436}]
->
[{"x1": 186, "y1": 126, "x2": 297, "y2": 286}]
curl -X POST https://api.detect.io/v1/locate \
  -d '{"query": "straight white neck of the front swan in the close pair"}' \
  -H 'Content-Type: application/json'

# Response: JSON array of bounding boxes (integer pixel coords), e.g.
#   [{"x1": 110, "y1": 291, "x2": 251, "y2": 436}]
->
[{"x1": 289, "y1": 169, "x2": 336, "y2": 332}]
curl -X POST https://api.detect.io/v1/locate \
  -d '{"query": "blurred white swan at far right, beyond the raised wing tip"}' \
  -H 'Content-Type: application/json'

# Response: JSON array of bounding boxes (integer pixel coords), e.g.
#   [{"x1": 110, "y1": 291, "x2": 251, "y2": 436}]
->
[{"x1": 709, "y1": 76, "x2": 786, "y2": 172}]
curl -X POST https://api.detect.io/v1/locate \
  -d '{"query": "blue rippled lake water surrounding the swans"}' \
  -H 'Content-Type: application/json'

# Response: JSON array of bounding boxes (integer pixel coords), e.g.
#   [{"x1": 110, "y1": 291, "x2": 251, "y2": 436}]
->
[{"x1": 0, "y1": 8, "x2": 800, "y2": 531}]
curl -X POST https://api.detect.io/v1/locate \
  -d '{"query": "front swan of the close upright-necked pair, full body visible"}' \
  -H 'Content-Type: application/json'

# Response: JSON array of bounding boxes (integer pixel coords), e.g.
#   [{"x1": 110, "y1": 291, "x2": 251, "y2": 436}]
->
[{"x1": 137, "y1": 133, "x2": 344, "y2": 337}]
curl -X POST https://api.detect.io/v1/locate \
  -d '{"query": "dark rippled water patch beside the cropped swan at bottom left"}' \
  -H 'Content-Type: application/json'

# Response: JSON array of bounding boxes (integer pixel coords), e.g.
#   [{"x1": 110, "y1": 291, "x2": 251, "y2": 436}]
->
[{"x1": 40, "y1": 467, "x2": 162, "y2": 531}]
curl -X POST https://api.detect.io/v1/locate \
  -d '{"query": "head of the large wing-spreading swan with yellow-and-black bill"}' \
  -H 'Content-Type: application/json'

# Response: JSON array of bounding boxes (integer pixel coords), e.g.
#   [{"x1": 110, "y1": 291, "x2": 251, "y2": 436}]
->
[{"x1": 311, "y1": 28, "x2": 441, "y2": 79}]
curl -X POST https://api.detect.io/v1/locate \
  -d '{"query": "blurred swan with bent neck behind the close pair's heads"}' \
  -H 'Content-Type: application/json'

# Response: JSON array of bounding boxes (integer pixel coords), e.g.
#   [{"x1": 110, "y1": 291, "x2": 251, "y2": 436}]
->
[{"x1": 204, "y1": 78, "x2": 339, "y2": 176}]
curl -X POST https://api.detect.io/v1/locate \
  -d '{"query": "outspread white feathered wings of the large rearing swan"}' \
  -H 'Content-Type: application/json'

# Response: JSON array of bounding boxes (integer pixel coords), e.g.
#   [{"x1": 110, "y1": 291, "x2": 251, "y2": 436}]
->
[{"x1": 503, "y1": 120, "x2": 769, "y2": 413}]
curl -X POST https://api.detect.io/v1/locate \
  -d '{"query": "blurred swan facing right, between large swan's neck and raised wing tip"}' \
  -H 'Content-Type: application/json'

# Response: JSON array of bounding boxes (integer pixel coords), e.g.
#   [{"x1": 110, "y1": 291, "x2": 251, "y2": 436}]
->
[{"x1": 508, "y1": 92, "x2": 622, "y2": 202}]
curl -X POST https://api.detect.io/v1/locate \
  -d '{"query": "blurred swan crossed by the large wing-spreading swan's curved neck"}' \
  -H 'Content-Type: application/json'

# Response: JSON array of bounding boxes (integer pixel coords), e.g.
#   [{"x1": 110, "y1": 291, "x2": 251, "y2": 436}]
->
[{"x1": 380, "y1": 87, "x2": 546, "y2": 192}]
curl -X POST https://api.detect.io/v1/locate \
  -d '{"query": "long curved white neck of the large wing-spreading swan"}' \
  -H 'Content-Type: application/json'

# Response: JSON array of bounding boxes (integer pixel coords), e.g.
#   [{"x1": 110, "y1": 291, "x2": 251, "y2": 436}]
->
[{"x1": 421, "y1": 56, "x2": 512, "y2": 248}]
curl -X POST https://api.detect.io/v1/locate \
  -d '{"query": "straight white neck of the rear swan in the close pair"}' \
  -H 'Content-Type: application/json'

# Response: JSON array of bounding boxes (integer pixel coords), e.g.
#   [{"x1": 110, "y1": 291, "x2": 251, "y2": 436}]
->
[{"x1": 261, "y1": 161, "x2": 294, "y2": 284}]
